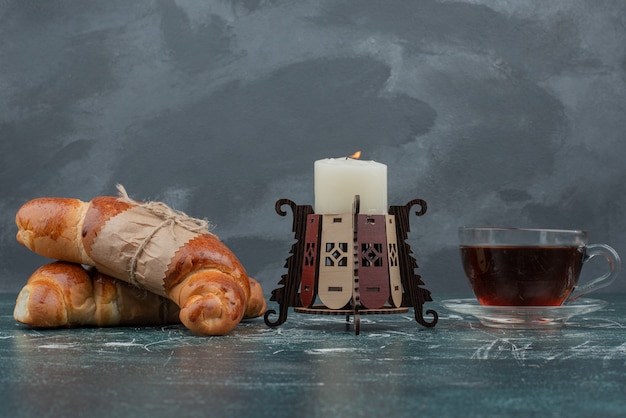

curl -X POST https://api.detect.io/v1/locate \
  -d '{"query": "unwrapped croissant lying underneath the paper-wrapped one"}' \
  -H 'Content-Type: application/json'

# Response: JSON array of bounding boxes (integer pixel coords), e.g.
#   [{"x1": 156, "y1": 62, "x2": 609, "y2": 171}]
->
[{"x1": 13, "y1": 261, "x2": 180, "y2": 328}]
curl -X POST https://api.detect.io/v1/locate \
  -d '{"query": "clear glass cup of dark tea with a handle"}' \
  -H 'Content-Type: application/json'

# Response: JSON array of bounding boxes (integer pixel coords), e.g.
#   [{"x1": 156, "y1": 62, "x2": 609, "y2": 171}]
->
[{"x1": 459, "y1": 227, "x2": 621, "y2": 306}]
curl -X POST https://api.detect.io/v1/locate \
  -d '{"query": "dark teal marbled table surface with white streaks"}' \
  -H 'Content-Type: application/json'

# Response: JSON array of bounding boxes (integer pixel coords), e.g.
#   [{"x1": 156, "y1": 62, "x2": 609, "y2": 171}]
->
[{"x1": 0, "y1": 294, "x2": 626, "y2": 418}]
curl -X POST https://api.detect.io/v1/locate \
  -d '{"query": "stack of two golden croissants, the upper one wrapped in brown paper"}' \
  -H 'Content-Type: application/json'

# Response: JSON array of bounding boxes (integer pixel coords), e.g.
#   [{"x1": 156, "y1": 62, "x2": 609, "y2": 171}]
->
[{"x1": 14, "y1": 185, "x2": 266, "y2": 335}]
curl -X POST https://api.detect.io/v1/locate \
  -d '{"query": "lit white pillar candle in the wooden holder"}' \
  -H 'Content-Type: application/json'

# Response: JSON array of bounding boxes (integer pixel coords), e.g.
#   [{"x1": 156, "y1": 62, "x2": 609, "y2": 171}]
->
[{"x1": 314, "y1": 157, "x2": 387, "y2": 215}]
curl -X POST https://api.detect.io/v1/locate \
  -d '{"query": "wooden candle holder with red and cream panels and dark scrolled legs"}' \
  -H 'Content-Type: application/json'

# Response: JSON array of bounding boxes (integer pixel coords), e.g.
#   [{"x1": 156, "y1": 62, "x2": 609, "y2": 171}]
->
[{"x1": 264, "y1": 195, "x2": 438, "y2": 335}]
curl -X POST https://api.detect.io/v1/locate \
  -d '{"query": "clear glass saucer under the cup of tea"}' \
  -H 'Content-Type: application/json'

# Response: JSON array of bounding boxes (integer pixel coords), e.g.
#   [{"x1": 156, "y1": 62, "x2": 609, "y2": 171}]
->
[{"x1": 441, "y1": 299, "x2": 608, "y2": 329}]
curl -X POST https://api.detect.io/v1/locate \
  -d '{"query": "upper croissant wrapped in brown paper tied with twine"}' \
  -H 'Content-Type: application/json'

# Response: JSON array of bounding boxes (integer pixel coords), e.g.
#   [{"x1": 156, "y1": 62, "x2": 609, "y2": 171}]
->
[{"x1": 15, "y1": 186, "x2": 265, "y2": 335}]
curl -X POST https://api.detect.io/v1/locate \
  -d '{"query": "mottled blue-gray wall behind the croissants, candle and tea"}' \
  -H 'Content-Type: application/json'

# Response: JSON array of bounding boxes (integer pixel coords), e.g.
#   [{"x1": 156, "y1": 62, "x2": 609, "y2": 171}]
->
[{"x1": 0, "y1": 0, "x2": 626, "y2": 298}]
